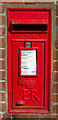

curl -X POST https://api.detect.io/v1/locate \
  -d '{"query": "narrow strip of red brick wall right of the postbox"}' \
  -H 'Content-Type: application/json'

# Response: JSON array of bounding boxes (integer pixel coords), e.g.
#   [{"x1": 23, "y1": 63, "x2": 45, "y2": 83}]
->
[{"x1": 53, "y1": 2, "x2": 58, "y2": 118}]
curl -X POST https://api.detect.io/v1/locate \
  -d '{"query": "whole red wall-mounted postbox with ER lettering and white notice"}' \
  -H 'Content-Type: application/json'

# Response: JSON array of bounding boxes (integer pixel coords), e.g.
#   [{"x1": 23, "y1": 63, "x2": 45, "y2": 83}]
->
[{"x1": 7, "y1": 8, "x2": 52, "y2": 113}]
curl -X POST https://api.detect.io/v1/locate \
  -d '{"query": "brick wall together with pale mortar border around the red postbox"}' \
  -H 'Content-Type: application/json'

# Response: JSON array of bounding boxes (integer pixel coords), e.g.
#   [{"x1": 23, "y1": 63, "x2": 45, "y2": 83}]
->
[{"x1": 0, "y1": 0, "x2": 58, "y2": 120}]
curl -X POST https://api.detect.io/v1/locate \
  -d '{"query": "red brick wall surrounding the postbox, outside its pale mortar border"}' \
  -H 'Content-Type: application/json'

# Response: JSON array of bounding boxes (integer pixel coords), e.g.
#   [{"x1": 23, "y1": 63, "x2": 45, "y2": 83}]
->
[{"x1": 0, "y1": 0, "x2": 58, "y2": 120}]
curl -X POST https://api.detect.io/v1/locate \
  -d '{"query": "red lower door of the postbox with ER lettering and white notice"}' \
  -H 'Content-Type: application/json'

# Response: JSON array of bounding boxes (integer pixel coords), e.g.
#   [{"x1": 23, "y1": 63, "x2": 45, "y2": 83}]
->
[{"x1": 13, "y1": 42, "x2": 44, "y2": 108}]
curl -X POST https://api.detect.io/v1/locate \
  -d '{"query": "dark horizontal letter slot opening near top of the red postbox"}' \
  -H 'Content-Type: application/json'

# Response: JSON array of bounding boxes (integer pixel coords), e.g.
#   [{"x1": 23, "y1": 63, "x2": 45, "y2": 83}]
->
[{"x1": 9, "y1": 24, "x2": 47, "y2": 31}]
